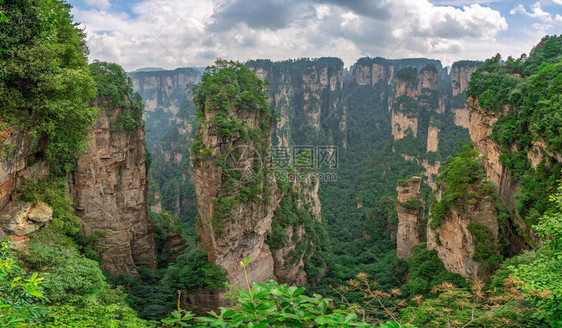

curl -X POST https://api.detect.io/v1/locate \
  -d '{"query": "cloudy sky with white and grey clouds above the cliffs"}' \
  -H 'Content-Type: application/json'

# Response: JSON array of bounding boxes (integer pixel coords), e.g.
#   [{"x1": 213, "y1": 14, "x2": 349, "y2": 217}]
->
[{"x1": 68, "y1": 0, "x2": 562, "y2": 71}]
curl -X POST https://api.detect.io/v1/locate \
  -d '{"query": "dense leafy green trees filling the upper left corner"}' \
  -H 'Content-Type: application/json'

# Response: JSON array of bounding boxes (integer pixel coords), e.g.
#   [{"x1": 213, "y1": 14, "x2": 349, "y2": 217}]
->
[{"x1": 0, "y1": 0, "x2": 98, "y2": 171}]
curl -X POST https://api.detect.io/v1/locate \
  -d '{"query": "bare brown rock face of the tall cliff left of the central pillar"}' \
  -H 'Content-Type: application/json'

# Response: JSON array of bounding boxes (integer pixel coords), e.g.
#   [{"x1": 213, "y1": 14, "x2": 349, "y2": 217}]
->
[{"x1": 68, "y1": 99, "x2": 156, "y2": 275}]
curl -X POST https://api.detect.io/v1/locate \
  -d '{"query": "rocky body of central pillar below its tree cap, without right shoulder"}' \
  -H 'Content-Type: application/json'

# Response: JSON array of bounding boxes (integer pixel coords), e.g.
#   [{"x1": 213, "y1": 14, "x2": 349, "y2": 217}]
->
[{"x1": 194, "y1": 67, "x2": 277, "y2": 294}]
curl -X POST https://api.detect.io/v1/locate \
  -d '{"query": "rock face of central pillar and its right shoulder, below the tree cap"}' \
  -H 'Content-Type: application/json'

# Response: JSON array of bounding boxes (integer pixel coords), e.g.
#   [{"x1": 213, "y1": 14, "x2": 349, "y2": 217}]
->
[{"x1": 193, "y1": 63, "x2": 320, "y2": 302}]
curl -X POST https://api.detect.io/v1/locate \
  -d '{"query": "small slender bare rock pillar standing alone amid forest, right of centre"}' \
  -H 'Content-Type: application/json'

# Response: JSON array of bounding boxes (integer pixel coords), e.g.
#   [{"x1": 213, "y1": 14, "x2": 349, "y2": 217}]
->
[{"x1": 396, "y1": 177, "x2": 425, "y2": 260}]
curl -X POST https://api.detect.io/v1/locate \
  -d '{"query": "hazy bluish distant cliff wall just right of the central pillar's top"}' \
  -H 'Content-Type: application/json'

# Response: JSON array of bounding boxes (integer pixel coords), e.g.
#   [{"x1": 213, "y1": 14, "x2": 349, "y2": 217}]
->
[{"x1": 246, "y1": 58, "x2": 346, "y2": 147}]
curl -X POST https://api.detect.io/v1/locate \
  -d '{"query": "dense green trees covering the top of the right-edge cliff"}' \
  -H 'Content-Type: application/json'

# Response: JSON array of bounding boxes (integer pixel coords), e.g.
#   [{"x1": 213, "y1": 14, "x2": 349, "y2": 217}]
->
[{"x1": 467, "y1": 36, "x2": 562, "y2": 224}]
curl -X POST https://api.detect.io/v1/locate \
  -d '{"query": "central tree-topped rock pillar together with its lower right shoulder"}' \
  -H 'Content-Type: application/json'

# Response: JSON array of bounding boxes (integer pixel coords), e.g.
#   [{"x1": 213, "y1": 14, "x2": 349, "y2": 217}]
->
[{"x1": 192, "y1": 61, "x2": 320, "y2": 302}]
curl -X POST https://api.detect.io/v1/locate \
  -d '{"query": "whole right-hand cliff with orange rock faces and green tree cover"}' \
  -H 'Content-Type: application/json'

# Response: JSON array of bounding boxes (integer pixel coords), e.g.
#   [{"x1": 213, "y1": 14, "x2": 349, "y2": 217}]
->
[{"x1": 416, "y1": 36, "x2": 562, "y2": 277}]
